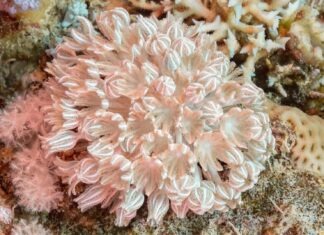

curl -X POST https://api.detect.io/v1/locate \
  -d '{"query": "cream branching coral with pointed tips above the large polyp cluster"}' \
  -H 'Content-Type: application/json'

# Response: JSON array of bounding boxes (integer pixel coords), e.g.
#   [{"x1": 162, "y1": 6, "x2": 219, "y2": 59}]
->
[{"x1": 130, "y1": 0, "x2": 302, "y2": 78}]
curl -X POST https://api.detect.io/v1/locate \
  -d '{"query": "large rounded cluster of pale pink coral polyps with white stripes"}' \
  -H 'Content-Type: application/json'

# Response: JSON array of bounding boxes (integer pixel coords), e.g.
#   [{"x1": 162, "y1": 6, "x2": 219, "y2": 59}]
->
[{"x1": 43, "y1": 8, "x2": 274, "y2": 226}]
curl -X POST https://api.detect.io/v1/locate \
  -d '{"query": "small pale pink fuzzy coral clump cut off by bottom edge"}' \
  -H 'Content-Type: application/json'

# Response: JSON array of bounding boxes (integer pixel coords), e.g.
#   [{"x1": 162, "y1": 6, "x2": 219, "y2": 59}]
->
[{"x1": 11, "y1": 219, "x2": 52, "y2": 235}]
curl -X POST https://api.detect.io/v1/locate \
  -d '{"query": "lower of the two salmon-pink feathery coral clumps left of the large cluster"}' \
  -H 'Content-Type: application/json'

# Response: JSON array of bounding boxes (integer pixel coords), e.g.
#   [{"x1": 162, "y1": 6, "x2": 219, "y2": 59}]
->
[{"x1": 11, "y1": 141, "x2": 63, "y2": 212}]
